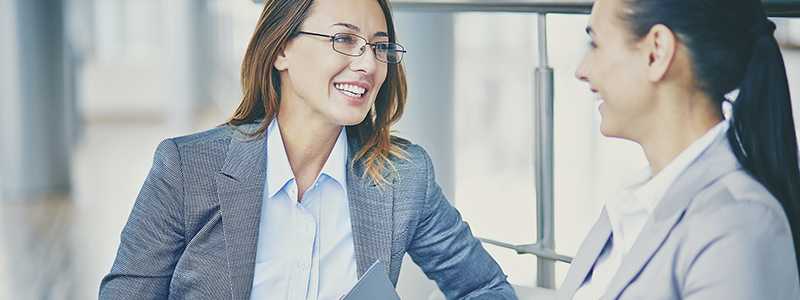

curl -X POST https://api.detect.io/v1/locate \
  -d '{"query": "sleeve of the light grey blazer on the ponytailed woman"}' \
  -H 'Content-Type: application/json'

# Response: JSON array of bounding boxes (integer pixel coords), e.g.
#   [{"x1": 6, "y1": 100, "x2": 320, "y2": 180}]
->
[{"x1": 682, "y1": 201, "x2": 800, "y2": 300}]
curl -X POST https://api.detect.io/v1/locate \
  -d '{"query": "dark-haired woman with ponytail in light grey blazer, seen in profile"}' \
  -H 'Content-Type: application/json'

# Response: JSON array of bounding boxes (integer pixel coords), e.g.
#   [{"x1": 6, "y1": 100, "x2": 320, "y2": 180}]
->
[{"x1": 560, "y1": 0, "x2": 800, "y2": 299}]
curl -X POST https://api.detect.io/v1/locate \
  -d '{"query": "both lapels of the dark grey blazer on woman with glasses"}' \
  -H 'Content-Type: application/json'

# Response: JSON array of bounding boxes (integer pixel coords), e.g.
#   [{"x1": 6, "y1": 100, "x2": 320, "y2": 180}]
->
[{"x1": 216, "y1": 123, "x2": 394, "y2": 299}]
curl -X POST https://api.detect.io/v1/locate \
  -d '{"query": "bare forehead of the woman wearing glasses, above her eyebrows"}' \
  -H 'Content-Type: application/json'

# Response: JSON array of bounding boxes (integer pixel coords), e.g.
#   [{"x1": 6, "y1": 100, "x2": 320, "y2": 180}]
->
[{"x1": 305, "y1": 0, "x2": 387, "y2": 35}]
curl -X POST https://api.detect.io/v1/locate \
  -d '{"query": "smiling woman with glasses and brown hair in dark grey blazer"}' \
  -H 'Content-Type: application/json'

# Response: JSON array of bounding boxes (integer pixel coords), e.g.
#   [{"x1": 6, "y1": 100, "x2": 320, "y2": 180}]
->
[{"x1": 100, "y1": 0, "x2": 515, "y2": 299}]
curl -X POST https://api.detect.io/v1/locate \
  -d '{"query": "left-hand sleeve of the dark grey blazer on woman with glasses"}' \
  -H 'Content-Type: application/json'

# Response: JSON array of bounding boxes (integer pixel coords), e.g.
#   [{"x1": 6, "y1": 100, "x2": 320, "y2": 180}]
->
[{"x1": 99, "y1": 139, "x2": 185, "y2": 299}]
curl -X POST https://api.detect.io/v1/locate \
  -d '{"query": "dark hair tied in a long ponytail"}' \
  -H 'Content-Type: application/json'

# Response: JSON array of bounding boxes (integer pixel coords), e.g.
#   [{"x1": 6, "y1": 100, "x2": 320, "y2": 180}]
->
[{"x1": 620, "y1": 0, "x2": 800, "y2": 267}]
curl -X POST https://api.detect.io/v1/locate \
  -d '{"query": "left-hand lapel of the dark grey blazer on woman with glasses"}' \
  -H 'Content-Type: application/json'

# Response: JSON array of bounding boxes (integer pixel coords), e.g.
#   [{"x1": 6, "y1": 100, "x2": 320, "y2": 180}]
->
[{"x1": 216, "y1": 125, "x2": 266, "y2": 299}]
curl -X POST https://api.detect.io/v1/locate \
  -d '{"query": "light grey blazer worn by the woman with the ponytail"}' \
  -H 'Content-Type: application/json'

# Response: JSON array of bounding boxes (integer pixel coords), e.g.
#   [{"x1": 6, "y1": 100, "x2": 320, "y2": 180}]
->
[{"x1": 558, "y1": 135, "x2": 800, "y2": 300}]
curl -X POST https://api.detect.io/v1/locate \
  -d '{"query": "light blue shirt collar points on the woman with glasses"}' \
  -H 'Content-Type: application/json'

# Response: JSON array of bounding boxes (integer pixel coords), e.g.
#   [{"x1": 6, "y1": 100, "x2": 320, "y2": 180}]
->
[{"x1": 266, "y1": 118, "x2": 348, "y2": 198}]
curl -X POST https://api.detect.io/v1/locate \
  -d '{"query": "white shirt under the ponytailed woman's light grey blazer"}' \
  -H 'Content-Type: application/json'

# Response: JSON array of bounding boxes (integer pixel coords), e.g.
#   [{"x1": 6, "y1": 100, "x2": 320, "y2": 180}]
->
[{"x1": 573, "y1": 120, "x2": 728, "y2": 300}]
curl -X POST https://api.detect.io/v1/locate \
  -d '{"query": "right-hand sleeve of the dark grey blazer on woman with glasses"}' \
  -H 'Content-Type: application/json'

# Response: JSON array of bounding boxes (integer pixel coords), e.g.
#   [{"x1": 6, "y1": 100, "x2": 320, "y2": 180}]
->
[{"x1": 408, "y1": 148, "x2": 517, "y2": 299}]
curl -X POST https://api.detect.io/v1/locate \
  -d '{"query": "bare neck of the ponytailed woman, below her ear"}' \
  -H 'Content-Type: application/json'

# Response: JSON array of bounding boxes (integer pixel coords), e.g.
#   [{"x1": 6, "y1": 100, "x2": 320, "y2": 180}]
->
[{"x1": 637, "y1": 89, "x2": 723, "y2": 175}]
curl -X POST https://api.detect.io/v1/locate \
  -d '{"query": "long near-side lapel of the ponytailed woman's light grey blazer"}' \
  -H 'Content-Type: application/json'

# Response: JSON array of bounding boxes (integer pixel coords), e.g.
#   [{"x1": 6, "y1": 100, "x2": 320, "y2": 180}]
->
[{"x1": 606, "y1": 134, "x2": 740, "y2": 299}]
